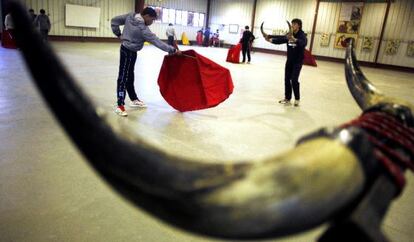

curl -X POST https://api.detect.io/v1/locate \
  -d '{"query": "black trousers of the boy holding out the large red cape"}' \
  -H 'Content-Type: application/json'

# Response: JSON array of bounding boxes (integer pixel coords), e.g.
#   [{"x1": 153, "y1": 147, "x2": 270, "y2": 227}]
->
[{"x1": 116, "y1": 45, "x2": 138, "y2": 106}]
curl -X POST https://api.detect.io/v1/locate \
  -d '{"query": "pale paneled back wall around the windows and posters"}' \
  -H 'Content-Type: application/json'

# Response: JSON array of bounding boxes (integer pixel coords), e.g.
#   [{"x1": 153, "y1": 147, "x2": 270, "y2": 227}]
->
[{"x1": 20, "y1": 0, "x2": 414, "y2": 67}]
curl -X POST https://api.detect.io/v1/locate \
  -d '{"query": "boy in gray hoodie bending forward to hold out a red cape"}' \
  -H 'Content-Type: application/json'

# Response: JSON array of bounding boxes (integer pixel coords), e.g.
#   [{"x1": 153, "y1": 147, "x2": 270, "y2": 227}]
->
[{"x1": 111, "y1": 7, "x2": 181, "y2": 117}]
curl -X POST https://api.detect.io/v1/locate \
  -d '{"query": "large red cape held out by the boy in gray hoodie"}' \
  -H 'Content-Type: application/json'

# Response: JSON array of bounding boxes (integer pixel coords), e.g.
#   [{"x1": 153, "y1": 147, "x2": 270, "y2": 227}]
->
[{"x1": 158, "y1": 50, "x2": 234, "y2": 112}]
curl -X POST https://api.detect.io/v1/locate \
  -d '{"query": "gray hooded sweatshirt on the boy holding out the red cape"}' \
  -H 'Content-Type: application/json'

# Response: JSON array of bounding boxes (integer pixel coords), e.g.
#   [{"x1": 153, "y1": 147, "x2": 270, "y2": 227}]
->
[{"x1": 111, "y1": 12, "x2": 176, "y2": 54}]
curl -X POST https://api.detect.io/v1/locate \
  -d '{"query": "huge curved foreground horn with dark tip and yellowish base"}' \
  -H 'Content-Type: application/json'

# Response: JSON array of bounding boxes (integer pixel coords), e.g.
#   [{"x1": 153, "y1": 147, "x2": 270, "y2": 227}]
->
[{"x1": 11, "y1": 1, "x2": 365, "y2": 238}]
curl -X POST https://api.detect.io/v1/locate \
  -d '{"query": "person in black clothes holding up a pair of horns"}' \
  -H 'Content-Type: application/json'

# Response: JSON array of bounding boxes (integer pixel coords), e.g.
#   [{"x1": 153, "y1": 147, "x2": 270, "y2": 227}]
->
[{"x1": 264, "y1": 18, "x2": 308, "y2": 107}]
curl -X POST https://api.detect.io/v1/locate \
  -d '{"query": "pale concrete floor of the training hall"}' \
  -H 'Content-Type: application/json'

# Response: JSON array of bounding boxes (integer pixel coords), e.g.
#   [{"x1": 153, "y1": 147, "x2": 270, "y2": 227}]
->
[{"x1": 0, "y1": 42, "x2": 414, "y2": 242}]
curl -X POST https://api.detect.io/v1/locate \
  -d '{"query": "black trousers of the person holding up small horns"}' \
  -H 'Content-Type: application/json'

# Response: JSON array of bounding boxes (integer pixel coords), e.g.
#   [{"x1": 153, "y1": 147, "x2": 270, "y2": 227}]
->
[{"x1": 285, "y1": 62, "x2": 303, "y2": 100}]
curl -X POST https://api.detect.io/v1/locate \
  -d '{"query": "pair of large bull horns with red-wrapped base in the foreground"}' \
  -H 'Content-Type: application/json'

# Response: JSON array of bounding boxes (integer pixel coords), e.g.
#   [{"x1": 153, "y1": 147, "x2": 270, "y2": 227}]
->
[{"x1": 11, "y1": 1, "x2": 414, "y2": 241}]
